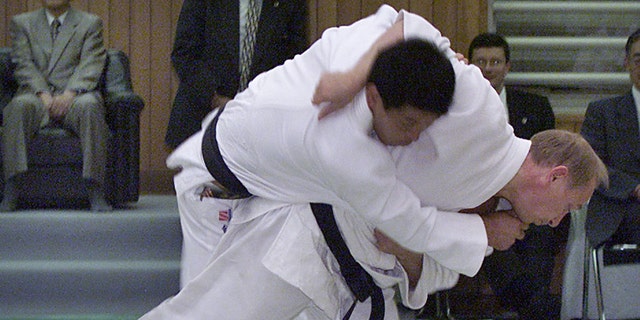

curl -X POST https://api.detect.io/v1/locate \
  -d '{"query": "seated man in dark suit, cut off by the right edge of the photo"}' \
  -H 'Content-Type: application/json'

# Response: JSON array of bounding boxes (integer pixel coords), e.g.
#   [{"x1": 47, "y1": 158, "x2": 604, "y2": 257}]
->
[{"x1": 581, "y1": 29, "x2": 640, "y2": 246}]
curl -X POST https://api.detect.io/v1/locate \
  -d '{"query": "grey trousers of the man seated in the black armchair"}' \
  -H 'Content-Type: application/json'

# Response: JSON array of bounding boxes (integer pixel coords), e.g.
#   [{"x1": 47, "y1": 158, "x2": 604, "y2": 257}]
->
[{"x1": 2, "y1": 92, "x2": 109, "y2": 185}]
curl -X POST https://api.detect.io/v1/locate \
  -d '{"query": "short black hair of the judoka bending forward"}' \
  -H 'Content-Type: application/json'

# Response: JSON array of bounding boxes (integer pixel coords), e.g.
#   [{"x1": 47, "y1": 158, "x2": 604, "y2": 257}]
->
[{"x1": 369, "y1": 39, "x2": 456, "y2": 115}]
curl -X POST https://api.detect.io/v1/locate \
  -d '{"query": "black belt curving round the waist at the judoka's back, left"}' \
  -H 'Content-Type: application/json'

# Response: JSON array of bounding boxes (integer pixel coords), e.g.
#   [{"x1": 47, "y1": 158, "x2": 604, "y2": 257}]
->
[{"x1": 202, "y1": 106, "x2": 251, "y2": 199}]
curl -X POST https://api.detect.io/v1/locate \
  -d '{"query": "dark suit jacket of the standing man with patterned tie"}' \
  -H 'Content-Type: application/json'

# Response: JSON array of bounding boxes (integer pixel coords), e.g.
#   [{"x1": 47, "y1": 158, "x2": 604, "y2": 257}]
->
[{"x1": 165, "y1": 0, "x2": 307, "y2": 147}]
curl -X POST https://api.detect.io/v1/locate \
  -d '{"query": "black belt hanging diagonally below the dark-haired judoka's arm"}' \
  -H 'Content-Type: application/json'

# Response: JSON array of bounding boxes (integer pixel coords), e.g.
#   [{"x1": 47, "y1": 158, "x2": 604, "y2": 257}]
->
[{"x1": 311, "y1": 203, "x2": 384, "y2": 320}]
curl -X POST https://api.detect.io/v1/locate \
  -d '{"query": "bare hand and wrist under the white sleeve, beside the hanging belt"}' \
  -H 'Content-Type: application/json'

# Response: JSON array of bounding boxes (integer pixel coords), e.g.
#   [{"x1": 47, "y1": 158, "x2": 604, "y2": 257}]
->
[{"x1": 373, "y1": 229, "x2": 422, "y2": 289}]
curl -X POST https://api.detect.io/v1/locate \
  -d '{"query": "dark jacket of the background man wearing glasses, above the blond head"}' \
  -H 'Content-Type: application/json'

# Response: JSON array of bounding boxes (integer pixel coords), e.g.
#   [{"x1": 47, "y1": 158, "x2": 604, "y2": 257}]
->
[{"x1": 507, "y1": 88, "x2": 555, "y2": 139}]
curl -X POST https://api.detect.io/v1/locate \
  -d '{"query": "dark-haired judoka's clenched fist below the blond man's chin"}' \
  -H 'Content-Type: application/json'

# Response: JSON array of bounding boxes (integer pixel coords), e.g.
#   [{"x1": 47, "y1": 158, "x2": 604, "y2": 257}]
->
[{"x1": 480, "y1": 210, "x2": 529, "y2": 250}]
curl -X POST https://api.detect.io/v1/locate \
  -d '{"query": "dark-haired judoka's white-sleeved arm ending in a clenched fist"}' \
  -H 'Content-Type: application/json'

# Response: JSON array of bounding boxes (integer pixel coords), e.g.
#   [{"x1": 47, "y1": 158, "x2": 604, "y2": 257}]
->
[{"x1": 323, "y1": 150, "x2": 488, "y2": 276}]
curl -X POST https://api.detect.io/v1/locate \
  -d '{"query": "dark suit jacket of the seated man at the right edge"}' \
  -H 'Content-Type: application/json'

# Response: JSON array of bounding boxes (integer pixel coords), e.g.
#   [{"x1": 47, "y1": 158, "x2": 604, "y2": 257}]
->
[{"x1": 581, "y1": 92, "x2": 640, "y2": 246}]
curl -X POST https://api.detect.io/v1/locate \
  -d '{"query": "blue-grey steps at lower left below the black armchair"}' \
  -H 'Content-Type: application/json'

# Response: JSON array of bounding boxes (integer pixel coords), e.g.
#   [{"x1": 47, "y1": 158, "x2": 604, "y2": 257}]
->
[{"x1": 0, "y1": 196, "x2": 182, "y2": 320}]
